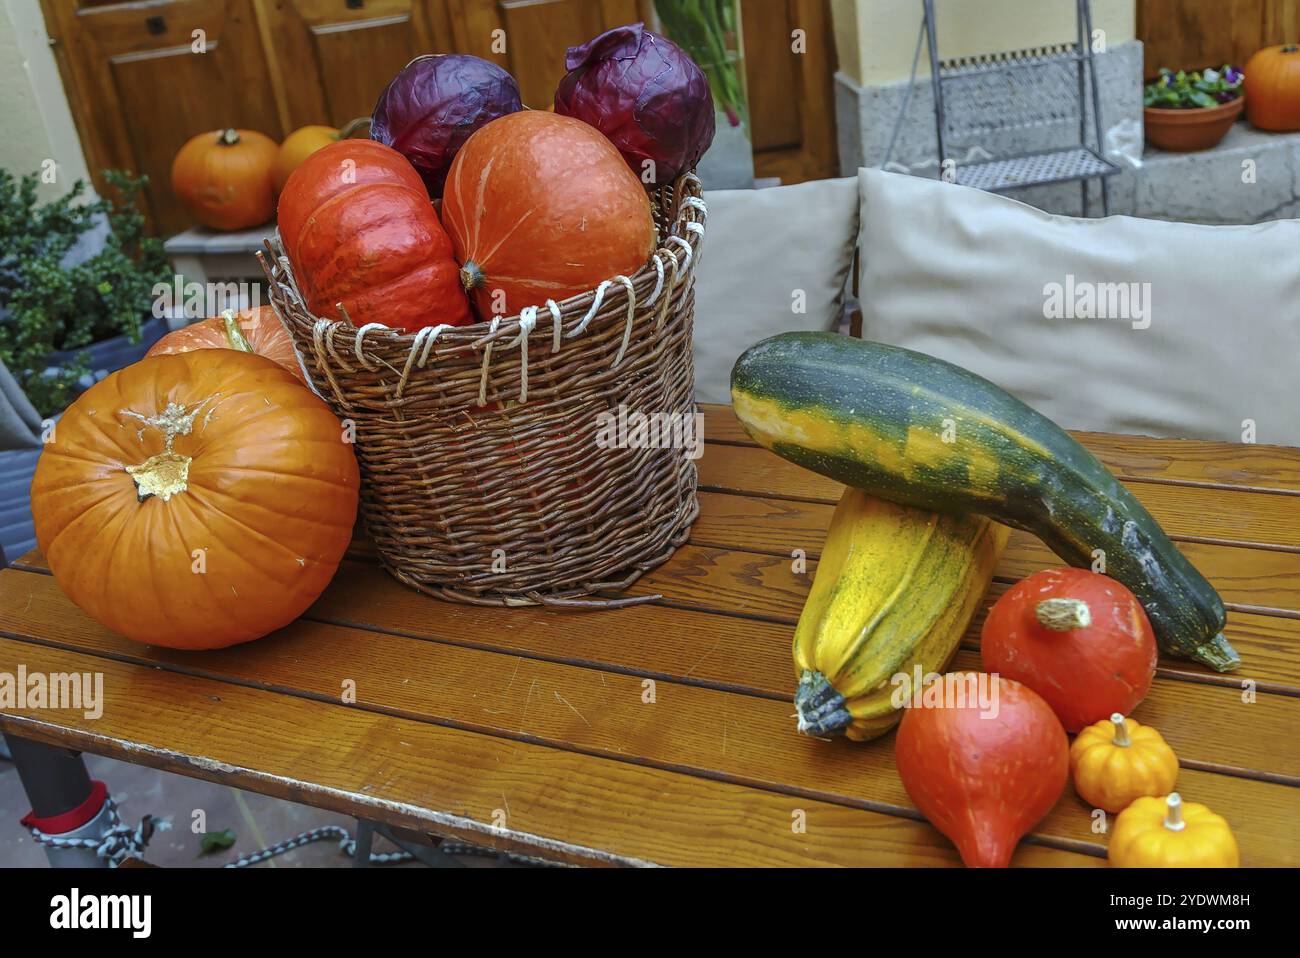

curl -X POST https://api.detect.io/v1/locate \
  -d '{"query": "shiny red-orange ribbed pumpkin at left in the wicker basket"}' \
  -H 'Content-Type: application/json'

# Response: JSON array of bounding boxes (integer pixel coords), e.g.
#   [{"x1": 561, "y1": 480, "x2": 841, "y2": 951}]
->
[{"x1": 280, "y1": 139, "x2": 473, "y2": 331}]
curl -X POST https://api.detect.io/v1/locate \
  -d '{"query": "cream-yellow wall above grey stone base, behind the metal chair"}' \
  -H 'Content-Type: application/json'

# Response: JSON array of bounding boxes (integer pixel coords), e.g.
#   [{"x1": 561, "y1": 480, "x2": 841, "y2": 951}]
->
[{"x1": 831, "y1": 0, "x2": 1136, "y2": 86}]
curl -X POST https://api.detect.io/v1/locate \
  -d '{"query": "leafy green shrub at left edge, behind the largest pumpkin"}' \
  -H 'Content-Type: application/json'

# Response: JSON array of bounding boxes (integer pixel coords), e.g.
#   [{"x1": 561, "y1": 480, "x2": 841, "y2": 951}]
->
[{"x1": 0, "y1": 170, "x2": 172, "y2": 415}]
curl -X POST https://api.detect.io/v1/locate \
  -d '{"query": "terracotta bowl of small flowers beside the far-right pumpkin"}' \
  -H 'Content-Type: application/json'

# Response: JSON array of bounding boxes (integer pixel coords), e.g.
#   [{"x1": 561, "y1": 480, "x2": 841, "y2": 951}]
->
[{"x1": 1143, "y1": 64, "x2": 1245, "y2": 153}]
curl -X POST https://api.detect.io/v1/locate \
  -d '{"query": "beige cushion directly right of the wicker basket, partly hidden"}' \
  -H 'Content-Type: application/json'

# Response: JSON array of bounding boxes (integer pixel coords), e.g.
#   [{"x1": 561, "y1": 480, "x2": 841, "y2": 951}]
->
[{"x1": 696, "y1": 177, "x2": 858, "y2": 403}]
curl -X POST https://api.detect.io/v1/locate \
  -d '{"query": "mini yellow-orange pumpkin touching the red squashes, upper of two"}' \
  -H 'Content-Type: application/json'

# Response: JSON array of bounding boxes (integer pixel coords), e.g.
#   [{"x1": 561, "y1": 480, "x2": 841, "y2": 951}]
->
[{"x1": 1070, "y1": 712, "x2": 1178, "y2": 812}]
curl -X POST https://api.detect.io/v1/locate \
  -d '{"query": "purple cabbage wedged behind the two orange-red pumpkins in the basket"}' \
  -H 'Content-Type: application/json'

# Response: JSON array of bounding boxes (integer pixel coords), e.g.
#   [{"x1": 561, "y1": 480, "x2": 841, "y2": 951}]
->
[{"x1": 371, "y1": 53, "x2": 524, "y2": 199}]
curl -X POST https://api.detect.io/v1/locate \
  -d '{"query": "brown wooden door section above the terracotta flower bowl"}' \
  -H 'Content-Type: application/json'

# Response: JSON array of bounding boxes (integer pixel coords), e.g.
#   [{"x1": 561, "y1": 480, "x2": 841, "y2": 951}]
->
[{"x1": 1138, "y1": 0, "x2": 1300, "y2": 77}]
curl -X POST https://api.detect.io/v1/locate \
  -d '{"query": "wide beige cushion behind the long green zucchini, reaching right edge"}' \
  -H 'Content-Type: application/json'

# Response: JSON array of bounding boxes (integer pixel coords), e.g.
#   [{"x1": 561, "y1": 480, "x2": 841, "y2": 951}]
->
[{"x1": 859, "y1": 170, "x2": 1300, "y2": 446}]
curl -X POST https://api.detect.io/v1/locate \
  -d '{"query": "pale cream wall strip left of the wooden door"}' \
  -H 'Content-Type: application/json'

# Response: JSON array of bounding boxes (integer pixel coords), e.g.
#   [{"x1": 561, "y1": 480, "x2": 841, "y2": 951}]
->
[{"x1": 0, "y1": 0, "x2": 90, "y2": 199}]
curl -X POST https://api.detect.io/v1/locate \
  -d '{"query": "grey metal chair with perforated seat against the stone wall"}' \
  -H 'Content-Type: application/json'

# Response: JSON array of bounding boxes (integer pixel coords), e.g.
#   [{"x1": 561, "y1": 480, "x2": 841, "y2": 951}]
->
[{"x1": 923, "y1": 0, "x2": 1119, "y2": 216}]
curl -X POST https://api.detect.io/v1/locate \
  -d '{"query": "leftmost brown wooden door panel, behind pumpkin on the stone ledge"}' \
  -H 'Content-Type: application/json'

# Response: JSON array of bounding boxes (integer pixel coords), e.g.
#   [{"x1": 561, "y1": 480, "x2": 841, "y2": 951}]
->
[{"x1": 42, "y1": 0, "x2": 285, "y2": 234}]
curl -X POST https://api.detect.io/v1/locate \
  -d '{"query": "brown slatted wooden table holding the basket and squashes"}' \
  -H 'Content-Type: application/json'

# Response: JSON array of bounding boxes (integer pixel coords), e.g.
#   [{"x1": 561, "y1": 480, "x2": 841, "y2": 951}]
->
[{"x1": 0, "y1": 407, "x2": 1300, "y2": 866}]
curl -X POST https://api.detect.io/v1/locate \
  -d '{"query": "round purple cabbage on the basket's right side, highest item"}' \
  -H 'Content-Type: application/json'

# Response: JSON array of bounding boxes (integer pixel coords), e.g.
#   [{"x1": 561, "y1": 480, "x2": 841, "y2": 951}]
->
[{"x1": 555, "y1": 23, "x2": 714, "y2": 187}]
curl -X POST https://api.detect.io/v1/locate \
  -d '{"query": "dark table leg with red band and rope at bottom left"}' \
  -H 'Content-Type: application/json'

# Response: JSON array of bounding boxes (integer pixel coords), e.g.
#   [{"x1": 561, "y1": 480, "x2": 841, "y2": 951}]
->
[{"x1": 5, "y1": 733, "x2": 109, "y2": 868}]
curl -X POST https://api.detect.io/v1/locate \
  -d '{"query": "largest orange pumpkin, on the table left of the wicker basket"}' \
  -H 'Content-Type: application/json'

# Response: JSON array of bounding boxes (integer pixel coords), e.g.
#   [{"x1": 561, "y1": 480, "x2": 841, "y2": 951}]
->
[{"x1": 31, "y1": 350, "x2": 359, "y2": 649}]
